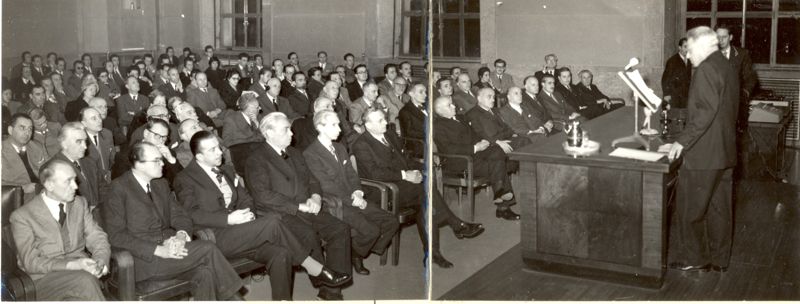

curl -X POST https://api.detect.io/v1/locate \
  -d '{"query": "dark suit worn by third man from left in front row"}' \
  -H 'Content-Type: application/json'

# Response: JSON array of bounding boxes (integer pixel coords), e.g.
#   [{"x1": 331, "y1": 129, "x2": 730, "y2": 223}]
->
[{"x1": 175, "y1": 160, "x2": 309, "y2": 300}]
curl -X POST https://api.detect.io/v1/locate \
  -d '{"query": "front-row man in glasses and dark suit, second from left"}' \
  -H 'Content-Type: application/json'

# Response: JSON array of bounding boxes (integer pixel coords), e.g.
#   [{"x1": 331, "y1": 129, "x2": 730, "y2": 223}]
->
[{"x1": 102, "y1": 142, "x2": 243, "y2": 301}]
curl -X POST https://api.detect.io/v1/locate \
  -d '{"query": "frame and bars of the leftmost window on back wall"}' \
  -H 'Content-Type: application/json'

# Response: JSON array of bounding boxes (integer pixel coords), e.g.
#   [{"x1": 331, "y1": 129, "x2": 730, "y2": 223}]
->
[{"x1": 214, "y1": 0, "x2": 264, "y2": 51}]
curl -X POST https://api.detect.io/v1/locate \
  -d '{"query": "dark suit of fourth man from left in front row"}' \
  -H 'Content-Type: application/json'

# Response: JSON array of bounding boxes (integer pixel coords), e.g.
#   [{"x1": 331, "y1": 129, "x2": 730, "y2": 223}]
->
[{"x1": 244, "y1": 142, "x2": 353, "y2": 282}]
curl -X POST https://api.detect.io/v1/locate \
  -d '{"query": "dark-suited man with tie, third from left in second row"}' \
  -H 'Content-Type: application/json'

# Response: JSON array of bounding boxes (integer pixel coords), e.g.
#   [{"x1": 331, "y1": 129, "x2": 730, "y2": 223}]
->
[{"x1": 81, "y1": 108, "x2": 116, "y2": 182}]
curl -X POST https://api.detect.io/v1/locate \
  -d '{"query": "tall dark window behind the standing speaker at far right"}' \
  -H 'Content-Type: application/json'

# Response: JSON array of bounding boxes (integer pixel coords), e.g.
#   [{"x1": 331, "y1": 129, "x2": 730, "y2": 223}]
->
[{"x1": 684, "y1": 0, "x2": 800, "y2": 66}]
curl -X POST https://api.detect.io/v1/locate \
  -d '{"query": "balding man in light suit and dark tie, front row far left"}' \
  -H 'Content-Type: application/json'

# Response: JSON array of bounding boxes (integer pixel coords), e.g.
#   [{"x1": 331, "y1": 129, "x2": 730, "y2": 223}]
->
[{"x1": 10, "y1": 160, "x2": 111, "y2": 301}]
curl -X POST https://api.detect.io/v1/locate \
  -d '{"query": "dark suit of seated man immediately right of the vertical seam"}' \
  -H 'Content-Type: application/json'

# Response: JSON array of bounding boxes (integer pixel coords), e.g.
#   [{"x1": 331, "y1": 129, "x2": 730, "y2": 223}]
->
[{"x1": 433, "y1": 116, "x2": 514, "y2": 199}]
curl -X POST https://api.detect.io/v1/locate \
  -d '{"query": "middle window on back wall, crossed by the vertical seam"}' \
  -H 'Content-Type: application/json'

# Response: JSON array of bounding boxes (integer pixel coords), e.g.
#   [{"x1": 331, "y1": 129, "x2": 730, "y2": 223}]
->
[{"x1": 400, "y1": 0, "x2": 481, "y2": 59}]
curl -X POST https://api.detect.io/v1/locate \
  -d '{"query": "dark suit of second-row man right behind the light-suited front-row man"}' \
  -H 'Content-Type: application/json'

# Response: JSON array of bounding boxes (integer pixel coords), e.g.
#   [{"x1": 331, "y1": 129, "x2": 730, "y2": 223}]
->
[{"x1": 53, "y1": 152, "x2": 109, "y2": 209}]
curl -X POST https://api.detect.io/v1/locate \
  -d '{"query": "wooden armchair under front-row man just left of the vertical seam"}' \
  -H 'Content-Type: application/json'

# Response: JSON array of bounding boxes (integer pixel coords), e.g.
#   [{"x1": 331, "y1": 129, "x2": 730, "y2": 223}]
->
[{"x1": 350, "y1": 155, "x2": 417, "y2": 266}]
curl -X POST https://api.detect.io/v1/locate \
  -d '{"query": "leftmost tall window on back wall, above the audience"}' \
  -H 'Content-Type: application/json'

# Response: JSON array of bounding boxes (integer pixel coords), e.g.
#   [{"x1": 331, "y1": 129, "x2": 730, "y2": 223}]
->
[{"x1": 219, "y1": 0, "x2": 261, "y2": 49}]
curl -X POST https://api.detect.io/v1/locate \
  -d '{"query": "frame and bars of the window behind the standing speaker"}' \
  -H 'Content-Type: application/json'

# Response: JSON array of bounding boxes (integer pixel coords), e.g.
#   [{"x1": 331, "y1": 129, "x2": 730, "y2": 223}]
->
[{"x1": 677, "y1": 0, "x2": 800, "y2": 70}]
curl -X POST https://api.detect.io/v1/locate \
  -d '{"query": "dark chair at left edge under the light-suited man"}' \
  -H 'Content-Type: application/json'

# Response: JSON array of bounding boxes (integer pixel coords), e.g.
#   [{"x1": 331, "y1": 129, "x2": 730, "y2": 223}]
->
[{"x1": 2, "y1": 186, "x2": 36, "y2": 301}]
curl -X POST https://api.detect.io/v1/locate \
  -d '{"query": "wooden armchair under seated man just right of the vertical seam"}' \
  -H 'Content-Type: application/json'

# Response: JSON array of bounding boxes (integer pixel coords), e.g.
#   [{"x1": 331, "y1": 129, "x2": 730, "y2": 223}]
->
[{"x1": 432, "y1": 145, "x2": 489, "y2": 222}]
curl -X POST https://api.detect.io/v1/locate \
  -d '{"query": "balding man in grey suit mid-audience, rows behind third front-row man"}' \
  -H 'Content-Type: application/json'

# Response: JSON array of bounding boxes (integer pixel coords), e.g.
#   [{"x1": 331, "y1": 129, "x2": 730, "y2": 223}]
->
[{"x1": 186, "y1": 72, "x2": 228, "y2": 127}]
